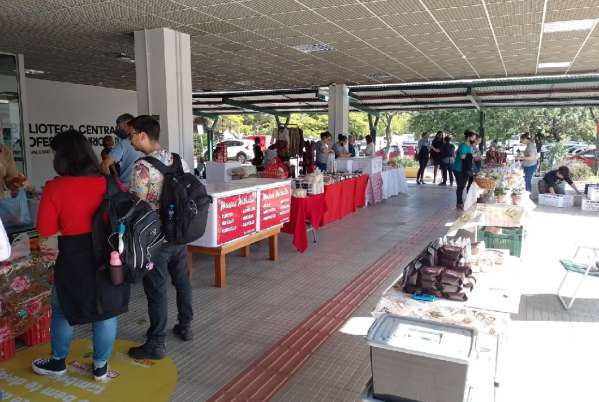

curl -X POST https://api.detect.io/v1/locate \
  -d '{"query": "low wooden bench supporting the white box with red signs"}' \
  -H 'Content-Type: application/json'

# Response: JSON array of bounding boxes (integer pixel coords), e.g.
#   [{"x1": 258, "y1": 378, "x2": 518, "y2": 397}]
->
[{"x1": 187, "y1": 225, "x2": 283, "y2": 288}]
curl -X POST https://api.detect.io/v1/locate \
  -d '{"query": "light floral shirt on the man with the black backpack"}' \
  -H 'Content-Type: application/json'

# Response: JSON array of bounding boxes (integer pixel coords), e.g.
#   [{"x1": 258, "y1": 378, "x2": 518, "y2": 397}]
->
[{"x1": 130, "y1": 149, "x2": 189, "y2": 209}]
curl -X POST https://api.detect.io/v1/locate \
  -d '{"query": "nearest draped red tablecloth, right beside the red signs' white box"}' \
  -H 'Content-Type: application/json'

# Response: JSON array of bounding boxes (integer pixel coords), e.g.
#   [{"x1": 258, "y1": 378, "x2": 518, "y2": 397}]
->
[{"x1": 283, "y1": 194, "x2": 327, "y2": 253}]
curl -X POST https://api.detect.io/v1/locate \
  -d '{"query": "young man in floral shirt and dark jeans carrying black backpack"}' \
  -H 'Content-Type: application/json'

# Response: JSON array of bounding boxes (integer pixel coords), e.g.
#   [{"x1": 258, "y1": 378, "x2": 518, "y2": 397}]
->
[{"x1": 129, "y1": 116, "x2": 193, "y2": 360}]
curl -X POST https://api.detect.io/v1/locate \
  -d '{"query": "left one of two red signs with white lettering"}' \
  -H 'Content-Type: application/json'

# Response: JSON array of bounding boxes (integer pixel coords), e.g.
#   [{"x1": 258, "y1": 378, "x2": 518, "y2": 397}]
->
[{"x1": 216, "y1": 191, "x2": 257, "y2": 244}]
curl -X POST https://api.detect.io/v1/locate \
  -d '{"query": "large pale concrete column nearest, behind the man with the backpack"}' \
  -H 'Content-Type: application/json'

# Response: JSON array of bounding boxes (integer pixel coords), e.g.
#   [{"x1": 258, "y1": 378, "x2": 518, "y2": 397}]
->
[{"x1": 135, "y1": 28, "x2": 193, "y2": 169}]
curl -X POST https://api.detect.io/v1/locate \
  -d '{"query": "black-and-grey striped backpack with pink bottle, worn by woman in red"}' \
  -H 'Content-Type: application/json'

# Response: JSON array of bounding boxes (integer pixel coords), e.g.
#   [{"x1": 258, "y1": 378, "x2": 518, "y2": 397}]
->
[{"x1": 92, "y1": 176, "x2": 164, "y2": 283}]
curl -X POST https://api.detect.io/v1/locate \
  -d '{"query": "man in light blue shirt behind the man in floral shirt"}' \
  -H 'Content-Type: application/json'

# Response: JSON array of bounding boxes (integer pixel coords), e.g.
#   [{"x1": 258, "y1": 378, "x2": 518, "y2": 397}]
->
[{"x1": 101, "y1": 113, "x2": 143, "y2": 188}]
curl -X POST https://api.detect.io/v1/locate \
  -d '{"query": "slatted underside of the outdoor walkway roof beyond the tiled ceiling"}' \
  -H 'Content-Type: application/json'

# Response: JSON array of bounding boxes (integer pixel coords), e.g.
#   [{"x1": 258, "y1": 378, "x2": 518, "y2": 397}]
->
[{"x1": 193, "y1": 74, "x2": 599, "y2": 115}]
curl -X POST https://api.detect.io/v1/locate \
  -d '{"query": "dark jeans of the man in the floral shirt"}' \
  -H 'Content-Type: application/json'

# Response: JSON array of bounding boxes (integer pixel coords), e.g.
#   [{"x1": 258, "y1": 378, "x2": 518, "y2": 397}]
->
[{"x1": 143, "y1": 243, "x2": 193, "y2": 343}]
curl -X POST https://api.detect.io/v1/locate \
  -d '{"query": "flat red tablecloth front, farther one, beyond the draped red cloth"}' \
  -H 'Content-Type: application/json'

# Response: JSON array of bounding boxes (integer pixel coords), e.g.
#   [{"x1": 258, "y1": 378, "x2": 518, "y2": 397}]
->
[{"x1": 321, "y1": 175, "x2": 368, "y2": 225}]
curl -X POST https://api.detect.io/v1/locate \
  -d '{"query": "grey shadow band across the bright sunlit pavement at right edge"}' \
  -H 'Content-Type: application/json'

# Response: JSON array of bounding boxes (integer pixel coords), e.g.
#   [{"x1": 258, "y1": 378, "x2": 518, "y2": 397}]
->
[{"x1": 511, "y1": 294, "x2": 599, "y2": 322}]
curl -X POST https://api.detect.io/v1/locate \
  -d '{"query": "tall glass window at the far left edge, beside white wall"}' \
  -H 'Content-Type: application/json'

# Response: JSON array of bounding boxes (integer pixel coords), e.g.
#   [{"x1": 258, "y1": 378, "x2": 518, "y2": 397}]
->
[{"x1": 0, "y1": 53, "x2": 25, "y2": 173}]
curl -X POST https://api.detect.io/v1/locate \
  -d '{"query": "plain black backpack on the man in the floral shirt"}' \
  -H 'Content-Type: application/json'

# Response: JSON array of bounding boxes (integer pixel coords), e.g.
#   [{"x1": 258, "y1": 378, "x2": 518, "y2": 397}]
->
[{"x1": 143, "y1": 153, "x2": 212, "y2": 244}]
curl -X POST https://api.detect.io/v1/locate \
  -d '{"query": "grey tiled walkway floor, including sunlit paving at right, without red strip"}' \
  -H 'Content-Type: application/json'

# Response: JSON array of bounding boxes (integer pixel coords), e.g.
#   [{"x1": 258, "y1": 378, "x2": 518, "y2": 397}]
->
[{"x1": 71, "y1": 185, "x2": 599, "y2": 402}]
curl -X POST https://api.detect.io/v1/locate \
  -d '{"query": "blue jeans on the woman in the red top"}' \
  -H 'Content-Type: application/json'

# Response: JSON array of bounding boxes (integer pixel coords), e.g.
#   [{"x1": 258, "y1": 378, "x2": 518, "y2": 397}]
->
[{"x1": 50, "y1": 289, "x2": 117, "y2": 367}]
